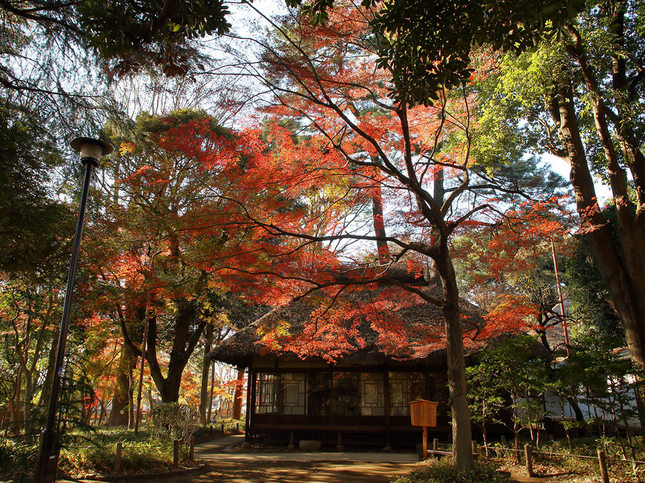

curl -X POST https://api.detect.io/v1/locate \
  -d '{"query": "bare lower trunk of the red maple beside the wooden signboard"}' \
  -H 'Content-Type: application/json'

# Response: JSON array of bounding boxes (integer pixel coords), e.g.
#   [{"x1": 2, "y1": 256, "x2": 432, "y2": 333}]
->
[{"x1": 435, "y1": 243, "x2": 473, "y2": 470}]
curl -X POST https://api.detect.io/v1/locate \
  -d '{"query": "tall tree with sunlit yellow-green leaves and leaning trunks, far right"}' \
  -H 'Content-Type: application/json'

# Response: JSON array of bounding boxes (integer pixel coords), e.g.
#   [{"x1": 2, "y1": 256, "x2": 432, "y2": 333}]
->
[{"x1": 468, "y1": 1, "x2": 645, "y2": 384}]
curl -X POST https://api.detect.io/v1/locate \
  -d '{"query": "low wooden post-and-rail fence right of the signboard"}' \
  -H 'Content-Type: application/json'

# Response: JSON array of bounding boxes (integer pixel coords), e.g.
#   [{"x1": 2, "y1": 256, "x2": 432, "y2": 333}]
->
[{"x1": 426, "y1": 439, "x2": 645, "y2": 483}]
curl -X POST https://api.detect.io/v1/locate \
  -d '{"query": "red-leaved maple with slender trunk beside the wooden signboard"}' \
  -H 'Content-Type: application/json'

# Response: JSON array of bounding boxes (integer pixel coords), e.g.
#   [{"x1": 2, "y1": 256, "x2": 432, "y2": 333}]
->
[{"x1": 216, "y1": 3, "x2": 532, "y2": 468}]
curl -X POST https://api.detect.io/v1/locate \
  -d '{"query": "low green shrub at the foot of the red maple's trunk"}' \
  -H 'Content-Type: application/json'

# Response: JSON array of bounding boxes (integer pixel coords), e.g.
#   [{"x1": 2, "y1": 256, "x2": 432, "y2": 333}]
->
[{"x1": 392, "y1": 459, "x2": 510, "y2": 483}]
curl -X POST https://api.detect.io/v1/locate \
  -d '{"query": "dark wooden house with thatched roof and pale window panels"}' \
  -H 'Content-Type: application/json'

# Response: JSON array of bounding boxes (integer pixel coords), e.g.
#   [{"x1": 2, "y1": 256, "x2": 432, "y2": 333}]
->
[{"x1": 210, "y1": 274, "x2": 482, "y2": 449}]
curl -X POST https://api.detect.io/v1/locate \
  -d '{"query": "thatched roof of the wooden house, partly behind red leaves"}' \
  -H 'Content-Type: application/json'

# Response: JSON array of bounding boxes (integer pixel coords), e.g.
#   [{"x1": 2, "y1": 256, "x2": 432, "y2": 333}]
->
[{"x1": 209, "y1": 283, "x2": 484, "y2": 367}]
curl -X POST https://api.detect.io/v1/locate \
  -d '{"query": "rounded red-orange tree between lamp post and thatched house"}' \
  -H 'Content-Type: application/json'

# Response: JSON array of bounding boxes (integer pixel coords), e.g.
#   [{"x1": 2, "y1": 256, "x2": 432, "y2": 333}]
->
[{"x1": 88, "y1": 111, "x2": 314, "y2": 402}]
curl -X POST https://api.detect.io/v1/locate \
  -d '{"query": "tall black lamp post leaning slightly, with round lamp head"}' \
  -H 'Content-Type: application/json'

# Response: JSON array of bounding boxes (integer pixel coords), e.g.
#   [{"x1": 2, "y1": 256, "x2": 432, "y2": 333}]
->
[{"x1": 36, "y1": 138, "x2": 112, "y2": 483}]
